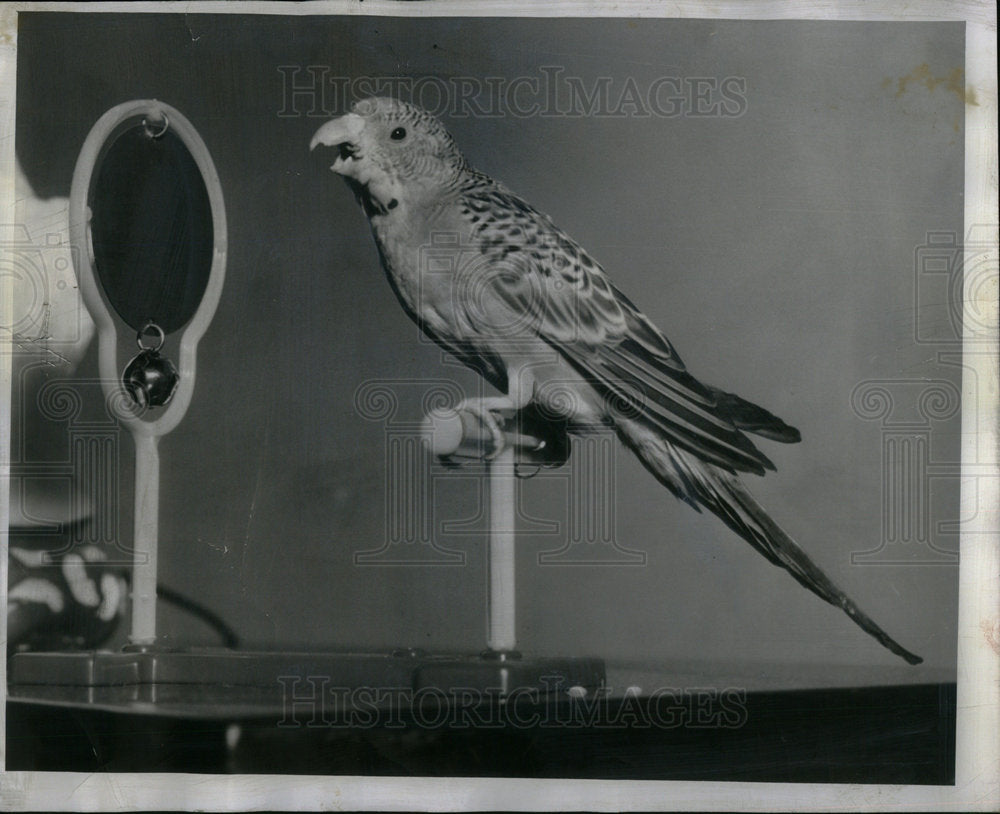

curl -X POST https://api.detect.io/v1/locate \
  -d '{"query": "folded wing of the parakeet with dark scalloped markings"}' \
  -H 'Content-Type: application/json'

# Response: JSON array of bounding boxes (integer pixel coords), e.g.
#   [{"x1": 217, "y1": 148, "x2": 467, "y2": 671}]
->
[{"x1": 468, "y1": 187, "x2": 777, "y2": 474}]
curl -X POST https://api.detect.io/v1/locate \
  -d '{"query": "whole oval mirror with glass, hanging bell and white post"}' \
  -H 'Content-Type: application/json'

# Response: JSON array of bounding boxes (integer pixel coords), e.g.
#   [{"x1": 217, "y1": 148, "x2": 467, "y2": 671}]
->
[{"x1": 70, "y1": 100, "x2": 226, "y2": 646}]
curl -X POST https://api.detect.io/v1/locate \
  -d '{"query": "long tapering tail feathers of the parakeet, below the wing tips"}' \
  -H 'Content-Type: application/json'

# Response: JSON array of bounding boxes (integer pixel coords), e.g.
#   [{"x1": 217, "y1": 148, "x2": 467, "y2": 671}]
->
[{"x1": 619, "y1": 425, "x2": 923, "y2": 664}]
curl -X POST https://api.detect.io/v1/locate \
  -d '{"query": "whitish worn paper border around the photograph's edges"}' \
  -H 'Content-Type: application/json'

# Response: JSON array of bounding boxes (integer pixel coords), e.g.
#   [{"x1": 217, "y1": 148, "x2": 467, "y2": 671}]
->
[{"x1": 0, "y1": 0, "x2": 1000, "y2": 811}]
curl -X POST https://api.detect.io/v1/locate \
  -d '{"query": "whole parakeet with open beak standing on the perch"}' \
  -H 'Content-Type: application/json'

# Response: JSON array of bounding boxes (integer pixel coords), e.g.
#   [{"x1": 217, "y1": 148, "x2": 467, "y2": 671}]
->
[{"x1": 311, "y1": 98, "x2": 922, "y2": 664}]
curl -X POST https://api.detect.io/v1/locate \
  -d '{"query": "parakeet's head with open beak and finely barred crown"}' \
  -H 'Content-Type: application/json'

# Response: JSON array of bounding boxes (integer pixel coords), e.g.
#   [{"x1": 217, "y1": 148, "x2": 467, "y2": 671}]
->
[{"x1": 309, "y1": 97, "x2": 466, "y2": 216}]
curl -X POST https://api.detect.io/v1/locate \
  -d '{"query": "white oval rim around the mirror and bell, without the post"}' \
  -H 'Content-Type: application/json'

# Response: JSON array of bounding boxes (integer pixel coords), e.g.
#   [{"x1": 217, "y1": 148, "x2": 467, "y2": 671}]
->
[{"x1": 69, "y1": 99, "x2": 227, "y2": 437}]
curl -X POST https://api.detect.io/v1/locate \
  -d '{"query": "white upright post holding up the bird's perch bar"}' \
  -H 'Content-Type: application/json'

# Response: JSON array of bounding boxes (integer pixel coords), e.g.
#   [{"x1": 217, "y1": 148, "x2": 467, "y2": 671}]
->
[{"x1": 487, "y1": 446, "x2": 516, "y2": 653}]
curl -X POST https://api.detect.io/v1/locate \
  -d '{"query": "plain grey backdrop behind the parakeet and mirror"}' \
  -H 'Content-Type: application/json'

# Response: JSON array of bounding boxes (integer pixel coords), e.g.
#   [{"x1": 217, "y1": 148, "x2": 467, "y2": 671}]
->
[{"x1": 16, "y1": 13, "x2": 964, "y2": 684}]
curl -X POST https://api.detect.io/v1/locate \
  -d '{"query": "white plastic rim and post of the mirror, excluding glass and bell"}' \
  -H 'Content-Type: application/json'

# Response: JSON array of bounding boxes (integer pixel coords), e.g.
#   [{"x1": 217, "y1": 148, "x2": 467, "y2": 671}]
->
[{"x1": 69, "y1": 99, "x2": 227, "y2": 647}]
